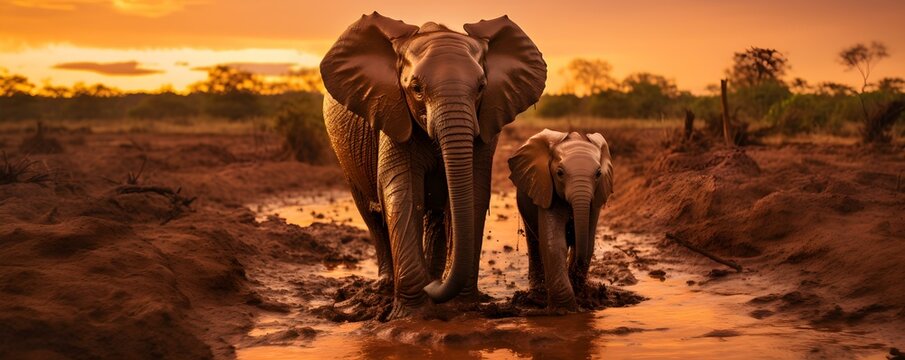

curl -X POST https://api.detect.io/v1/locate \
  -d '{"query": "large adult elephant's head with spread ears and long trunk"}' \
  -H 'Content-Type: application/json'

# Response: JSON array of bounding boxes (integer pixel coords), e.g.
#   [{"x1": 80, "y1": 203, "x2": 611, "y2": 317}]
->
[{"x1": 320, "y1": 12, "x2": 547, "y2": 302}]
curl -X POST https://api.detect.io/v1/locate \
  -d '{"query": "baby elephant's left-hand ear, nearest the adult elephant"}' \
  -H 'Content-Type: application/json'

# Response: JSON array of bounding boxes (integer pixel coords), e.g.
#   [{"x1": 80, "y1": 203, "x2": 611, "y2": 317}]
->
[{"x1": 509, "y1": 129, "x2": 566, "y2": 209}]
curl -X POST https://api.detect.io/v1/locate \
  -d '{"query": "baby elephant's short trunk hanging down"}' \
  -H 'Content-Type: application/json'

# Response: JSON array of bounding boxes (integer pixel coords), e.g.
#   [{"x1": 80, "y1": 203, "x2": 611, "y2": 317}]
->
[{"x1": 569, "y1": 184, "x2": 594, "y2": 292}]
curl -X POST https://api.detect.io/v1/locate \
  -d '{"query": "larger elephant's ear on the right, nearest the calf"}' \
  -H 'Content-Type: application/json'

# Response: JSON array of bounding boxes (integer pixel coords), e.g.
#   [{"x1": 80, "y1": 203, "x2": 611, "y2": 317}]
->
[{"x1": 465, "y1": 16, "x2": 547, "y2": 143}]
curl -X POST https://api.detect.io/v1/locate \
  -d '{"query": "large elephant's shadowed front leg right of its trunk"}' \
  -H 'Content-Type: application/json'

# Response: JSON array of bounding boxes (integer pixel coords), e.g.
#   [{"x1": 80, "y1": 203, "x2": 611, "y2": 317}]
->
[{"x1": 461, "y1": 136, "x2": 499, "y2": 300}]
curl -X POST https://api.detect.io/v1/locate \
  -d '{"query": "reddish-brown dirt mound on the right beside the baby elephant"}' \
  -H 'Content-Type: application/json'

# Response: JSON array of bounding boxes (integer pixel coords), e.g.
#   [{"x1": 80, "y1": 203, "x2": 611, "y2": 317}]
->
[{"x1": 604, "y1": 142, "x2": 905, "y2": 334}]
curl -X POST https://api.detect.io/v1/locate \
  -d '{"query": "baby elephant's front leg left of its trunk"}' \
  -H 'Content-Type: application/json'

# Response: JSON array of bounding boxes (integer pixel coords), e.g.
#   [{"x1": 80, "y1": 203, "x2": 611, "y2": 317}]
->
[{"x1": 538, "y1": 206, "x2": 578, "y2": 311}]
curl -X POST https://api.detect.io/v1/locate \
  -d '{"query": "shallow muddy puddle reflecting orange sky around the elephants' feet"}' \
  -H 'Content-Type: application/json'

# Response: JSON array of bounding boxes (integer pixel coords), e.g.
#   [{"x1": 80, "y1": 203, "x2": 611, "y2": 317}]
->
[{"x1": 237, "y1": 192, "x2": 888, "y2": 360}]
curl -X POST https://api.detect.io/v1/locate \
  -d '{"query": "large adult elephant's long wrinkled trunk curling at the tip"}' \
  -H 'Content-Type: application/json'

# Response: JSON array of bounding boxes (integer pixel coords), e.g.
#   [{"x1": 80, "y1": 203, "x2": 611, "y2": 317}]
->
[{"x1": 424, "y1": 106, "x2": 476, "y2": 303}]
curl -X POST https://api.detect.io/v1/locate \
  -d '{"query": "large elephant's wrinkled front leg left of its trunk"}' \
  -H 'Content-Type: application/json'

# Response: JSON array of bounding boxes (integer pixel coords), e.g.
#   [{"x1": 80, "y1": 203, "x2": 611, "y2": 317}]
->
[{"x1": 377, "y1": 136, "x2": 430, "y2": 319}]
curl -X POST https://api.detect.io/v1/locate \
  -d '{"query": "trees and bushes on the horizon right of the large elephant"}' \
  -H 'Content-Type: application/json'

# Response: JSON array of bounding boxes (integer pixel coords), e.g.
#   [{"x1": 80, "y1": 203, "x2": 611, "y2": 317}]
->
[{"x1": 535, "y1": 42, "x2": 905, "y2": 142}]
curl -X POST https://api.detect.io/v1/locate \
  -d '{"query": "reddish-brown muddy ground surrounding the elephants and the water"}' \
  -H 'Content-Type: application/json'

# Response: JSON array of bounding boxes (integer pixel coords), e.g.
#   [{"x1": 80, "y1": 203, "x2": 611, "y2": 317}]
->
[{"x1": 0, "y1": 119, "x2": 905, "y2": 358}]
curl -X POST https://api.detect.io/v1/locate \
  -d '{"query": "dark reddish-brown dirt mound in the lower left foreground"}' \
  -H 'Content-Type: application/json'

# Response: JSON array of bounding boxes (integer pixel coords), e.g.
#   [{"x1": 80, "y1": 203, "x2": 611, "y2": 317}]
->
[{"x1": 0, "y1": 187, "x2": 228, "y2": 358}]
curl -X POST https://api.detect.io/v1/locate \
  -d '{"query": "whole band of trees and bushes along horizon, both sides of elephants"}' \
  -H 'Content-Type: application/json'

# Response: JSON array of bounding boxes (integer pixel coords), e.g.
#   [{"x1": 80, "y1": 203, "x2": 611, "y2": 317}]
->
[{"x1": 0, "y1": 42, "x2": 905, "y2": 152}]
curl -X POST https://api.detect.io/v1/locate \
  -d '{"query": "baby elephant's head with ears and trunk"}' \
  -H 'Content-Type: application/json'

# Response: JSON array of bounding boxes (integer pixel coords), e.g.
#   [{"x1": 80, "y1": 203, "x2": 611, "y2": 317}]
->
[{"x1": 509, "y1": 129, "x2": 613, "y2": 296}]
